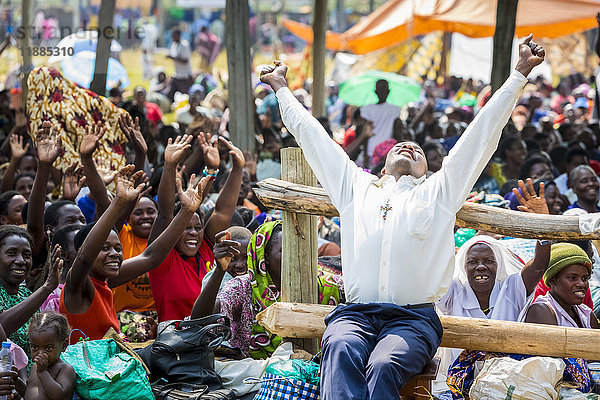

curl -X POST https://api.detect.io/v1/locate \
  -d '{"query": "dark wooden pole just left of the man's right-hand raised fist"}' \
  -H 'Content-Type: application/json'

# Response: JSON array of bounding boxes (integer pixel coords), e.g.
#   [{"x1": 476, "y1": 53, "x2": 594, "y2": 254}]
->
[{"x1": 491, "y1": 0, "x2": 519, "y2": 93}]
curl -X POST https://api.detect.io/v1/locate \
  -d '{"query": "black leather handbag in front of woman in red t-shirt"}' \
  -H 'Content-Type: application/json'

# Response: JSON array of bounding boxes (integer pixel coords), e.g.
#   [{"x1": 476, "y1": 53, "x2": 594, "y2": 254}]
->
[{"x1": 138, "y1": 314, "x2": 231, "y2": 390}]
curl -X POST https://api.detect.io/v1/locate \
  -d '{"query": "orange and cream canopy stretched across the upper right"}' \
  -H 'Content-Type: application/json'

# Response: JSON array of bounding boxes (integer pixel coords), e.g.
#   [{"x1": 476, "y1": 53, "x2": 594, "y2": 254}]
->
[{"x1": 283, "y1": 0, "x2": 600, "y2": 54}]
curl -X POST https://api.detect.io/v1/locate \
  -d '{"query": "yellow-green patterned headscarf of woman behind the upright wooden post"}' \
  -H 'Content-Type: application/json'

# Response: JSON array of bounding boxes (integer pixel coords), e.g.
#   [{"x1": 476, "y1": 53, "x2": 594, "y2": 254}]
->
[{"x1": 248, "y1": 221, "x2": 341, "y2": 359}]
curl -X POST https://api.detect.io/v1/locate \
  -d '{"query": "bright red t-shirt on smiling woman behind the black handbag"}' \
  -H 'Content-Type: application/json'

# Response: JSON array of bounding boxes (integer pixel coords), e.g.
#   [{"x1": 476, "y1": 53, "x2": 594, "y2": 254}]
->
[{"x1": 149, "y1": 236, "x2": 215, "y2": 322}]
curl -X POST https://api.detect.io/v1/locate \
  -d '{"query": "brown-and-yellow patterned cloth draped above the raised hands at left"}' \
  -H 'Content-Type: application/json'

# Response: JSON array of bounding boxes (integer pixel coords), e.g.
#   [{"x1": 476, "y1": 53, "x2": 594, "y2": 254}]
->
[{"x1": 27, "y1": 67, "x2": 126, "y2": 171}]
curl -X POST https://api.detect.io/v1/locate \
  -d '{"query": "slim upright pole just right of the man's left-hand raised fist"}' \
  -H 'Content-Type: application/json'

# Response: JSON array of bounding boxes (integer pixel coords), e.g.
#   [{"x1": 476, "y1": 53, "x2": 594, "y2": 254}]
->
[{"x1": 312, "y1": 0, "x2": 327, "y2": 117}]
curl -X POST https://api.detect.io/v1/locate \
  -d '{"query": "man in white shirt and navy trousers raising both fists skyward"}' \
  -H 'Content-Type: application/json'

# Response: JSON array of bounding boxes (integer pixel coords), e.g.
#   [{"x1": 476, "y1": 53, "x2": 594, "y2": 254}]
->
[{"x1": 261, "y1": 35, "x2": 545, "y2": 400}]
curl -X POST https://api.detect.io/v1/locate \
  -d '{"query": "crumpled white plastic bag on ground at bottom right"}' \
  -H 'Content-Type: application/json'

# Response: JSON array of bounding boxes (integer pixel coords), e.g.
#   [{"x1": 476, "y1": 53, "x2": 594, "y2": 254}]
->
[{"x1": 469, "y1": 357, "x2": 565, "y2": 400}]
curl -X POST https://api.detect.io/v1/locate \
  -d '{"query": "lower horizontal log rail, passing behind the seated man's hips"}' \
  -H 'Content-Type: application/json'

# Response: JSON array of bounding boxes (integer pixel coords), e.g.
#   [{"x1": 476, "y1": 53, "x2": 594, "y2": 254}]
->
[{"x1": 256, "y1": 303, "x2": 600, "y2": 360}]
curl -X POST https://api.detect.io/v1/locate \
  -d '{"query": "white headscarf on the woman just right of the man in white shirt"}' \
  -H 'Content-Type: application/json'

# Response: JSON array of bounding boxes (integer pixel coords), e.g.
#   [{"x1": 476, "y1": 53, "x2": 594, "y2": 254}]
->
[{"x1": 454, "y1": 235, "x2": 524, "y2": 285}]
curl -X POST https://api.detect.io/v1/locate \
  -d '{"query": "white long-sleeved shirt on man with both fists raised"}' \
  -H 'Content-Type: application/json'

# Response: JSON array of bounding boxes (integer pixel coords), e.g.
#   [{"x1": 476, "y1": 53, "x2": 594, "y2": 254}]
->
[{"x1": 277, "y1": 71, "x2": 527, "y2": 305}]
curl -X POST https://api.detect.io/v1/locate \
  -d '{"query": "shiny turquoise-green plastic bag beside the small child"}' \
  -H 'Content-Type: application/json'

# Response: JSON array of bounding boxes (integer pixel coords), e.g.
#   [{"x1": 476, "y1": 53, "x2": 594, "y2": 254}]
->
[{"x1": 61, "y1": 339, "x2": 154, "y2": 400}]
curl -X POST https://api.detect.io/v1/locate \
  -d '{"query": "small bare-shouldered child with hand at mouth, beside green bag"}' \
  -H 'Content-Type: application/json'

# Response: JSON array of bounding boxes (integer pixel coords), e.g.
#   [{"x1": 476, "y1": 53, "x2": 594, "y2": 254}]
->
[{"x1": 25, "y1": 311, "x2": 75, "y2": 400}]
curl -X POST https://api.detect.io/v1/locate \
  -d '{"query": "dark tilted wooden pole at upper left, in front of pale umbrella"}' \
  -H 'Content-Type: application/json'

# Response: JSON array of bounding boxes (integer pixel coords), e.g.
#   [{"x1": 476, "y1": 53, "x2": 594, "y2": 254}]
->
[{"x1": 90, "y1": 0, "x2": 116, "y2": 96}]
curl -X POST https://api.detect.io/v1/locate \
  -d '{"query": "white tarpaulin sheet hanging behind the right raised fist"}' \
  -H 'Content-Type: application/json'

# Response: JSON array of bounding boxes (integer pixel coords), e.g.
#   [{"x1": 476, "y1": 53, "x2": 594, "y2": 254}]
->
[{"x1": 448, "y1": 33, "x2": 552, "y2": 82}]
